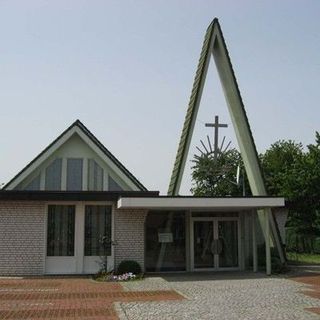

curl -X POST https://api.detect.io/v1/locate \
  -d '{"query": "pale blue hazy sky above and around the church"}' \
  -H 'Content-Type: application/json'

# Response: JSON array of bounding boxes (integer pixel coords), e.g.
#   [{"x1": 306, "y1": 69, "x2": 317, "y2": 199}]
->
[{"x1": 0, "y1": 0, "x2": 320, "y2": 194}]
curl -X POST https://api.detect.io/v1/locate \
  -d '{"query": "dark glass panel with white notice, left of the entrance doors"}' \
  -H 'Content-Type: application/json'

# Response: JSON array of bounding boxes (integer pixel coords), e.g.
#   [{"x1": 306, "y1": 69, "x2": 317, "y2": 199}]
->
[{"x1": 146, "y1": 211, "x2": 186, "y2": 271}]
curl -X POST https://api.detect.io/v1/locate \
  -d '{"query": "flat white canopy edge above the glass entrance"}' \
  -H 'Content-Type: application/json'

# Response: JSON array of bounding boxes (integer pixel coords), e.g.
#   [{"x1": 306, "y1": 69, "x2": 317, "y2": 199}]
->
[{"x1": 117, "y1": 196, "x2": 285, "y2": 211}]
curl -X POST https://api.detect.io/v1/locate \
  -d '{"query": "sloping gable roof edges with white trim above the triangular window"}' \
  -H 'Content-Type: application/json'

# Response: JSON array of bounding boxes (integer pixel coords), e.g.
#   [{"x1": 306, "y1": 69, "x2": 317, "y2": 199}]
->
[{"x1": 3, "y1": 120, "x2": 147, "y2": 191}]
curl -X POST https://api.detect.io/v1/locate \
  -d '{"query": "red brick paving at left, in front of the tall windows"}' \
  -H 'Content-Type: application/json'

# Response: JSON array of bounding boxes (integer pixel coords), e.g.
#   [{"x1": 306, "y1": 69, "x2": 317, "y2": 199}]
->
[{"x1": 0, "y1": 277, "x2": 183, "y2": 320}]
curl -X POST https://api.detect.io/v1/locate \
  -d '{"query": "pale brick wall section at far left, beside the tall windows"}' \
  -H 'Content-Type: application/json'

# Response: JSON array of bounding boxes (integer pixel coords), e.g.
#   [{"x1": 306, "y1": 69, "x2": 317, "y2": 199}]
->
[{"x1": 0, "y1": 201, "x2": 45, "y2": 276}]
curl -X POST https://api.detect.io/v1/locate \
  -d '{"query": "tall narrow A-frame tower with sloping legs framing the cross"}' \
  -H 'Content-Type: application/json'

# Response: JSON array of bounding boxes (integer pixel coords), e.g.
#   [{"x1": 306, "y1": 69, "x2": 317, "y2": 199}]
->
[{"x1": 168, "y1": 18, "x2": 285, "y2": 261}]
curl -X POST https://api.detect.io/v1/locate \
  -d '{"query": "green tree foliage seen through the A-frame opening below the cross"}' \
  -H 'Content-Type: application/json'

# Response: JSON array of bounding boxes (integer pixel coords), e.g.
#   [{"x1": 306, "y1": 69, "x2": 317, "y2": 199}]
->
[{"x1": 191, "y1": 149, "x2": 250, "y2": 196}]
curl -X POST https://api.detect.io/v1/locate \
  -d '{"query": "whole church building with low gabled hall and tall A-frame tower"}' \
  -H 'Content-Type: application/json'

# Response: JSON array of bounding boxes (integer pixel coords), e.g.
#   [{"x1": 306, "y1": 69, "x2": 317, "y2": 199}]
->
[{"x1": 0, "y1": 19, "x2": 286, "y2": 276}]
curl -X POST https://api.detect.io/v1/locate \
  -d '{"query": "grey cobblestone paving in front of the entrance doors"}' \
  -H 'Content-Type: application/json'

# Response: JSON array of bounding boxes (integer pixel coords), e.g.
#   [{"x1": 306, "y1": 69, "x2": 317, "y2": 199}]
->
[{"x1": 117, "y1": 273, "x2": 320, "y2": 320}]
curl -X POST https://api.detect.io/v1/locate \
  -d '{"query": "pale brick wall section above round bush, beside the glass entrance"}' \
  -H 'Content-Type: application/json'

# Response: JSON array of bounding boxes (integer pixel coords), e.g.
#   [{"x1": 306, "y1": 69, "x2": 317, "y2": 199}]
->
[{"x1": 114, "y1": 209, "x2": 147, "y2": 270}]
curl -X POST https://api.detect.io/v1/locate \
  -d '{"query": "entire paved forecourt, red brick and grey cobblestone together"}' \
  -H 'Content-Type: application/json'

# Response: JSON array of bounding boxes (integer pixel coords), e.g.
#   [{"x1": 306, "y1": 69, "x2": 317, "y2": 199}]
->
[{"x1": 0, "y1": 272, "x2": 320, "y2": 320}]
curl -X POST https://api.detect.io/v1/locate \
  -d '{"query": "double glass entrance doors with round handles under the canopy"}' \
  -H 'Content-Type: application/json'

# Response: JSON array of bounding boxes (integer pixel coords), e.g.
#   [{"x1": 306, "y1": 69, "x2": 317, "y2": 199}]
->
[{"x1": 191, "y1": 218, "x2": 239, "y2": 270}]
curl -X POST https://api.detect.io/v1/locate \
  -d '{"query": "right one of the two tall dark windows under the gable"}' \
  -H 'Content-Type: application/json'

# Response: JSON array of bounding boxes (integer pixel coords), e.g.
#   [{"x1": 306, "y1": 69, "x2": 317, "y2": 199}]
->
[{"x1": 84, "y1": 206, "x2": 111, "y2": 256}]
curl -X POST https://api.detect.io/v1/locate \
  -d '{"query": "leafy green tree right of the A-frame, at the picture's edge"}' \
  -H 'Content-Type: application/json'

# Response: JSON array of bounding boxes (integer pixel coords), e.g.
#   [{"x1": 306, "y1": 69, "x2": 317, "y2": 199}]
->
[{"x1": 261, "y1": 133, "x2": 320, "y2": 252}]
